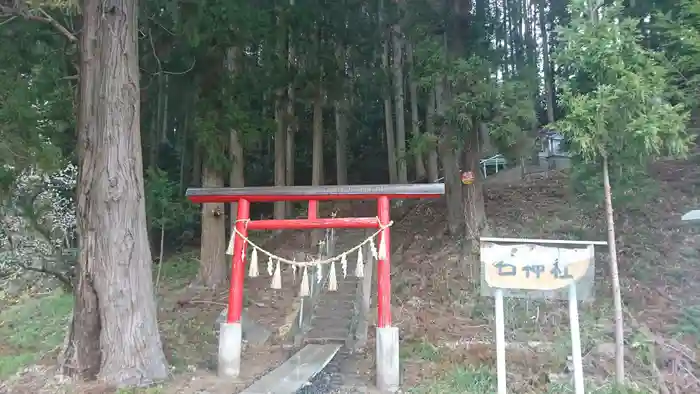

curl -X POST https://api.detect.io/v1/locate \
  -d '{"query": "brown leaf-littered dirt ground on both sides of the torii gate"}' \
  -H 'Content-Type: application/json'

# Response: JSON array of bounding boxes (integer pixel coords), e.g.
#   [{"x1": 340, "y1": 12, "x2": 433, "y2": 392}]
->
[{"x1": 0, "y1": 159, "x2": 700, "y2": 394}]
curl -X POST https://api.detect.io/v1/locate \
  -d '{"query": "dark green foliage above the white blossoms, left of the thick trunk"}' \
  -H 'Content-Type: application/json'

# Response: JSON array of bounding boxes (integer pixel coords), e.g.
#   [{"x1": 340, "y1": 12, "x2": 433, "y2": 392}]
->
[{"x1": 0, "y1": 20, "x2": 73, "y2": 189}]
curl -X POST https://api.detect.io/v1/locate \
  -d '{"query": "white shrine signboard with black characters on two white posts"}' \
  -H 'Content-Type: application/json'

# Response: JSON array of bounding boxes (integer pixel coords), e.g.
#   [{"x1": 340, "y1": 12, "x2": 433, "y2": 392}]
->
[{"x1": 481, "y1": 238, "x2": 605, "y2": 394}]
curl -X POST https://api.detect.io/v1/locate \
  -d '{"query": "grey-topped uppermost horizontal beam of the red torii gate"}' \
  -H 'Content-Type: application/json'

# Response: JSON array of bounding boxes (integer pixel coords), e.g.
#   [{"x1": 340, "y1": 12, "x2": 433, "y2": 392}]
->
[{"x1": 186, "y1": 183, "x2": 445, "y2": 204}]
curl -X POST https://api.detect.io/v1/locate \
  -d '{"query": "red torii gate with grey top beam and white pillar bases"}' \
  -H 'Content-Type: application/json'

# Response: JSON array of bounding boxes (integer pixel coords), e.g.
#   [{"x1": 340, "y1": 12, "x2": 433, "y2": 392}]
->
[{"x1": 186, "y1": 183, "x2": 445, "y2": 390}]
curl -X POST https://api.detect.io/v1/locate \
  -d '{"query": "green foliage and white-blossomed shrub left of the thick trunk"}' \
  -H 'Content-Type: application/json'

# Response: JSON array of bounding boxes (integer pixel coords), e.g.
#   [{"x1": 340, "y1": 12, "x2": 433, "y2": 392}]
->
[{"x1": 0, "y1": 14, "x2": 77, "y2": 288}]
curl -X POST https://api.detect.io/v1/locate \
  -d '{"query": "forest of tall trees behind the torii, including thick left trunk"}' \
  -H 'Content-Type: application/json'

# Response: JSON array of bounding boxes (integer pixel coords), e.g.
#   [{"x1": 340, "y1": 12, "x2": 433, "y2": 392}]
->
[{"x1": 0, "y1": 0, "x2": 700, "y2": 385}]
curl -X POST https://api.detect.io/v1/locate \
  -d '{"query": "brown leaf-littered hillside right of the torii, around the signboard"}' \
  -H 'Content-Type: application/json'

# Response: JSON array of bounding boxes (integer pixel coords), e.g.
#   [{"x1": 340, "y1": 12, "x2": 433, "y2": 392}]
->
[{"x1": 394, "y1": 160, "x2": 700, "y2": 393}]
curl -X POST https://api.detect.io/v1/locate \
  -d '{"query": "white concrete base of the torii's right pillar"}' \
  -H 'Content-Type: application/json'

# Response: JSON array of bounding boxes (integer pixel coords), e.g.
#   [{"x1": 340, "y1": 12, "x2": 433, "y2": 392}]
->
[{"x1": 376, "y1": 327, "x2": 401, "y2": 393}]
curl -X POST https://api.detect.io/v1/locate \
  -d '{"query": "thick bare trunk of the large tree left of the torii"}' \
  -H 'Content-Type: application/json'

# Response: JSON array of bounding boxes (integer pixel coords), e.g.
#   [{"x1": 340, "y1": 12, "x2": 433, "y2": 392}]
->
[{"x1": 65, "y1": 0, "x2": 168, "y2": 385}]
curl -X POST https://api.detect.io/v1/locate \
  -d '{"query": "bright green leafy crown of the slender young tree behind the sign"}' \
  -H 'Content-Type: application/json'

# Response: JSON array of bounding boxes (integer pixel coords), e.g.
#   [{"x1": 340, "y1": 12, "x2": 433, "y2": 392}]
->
[{"x1": 552, "y1": 1, "x2": 692, "y2": 165}]
